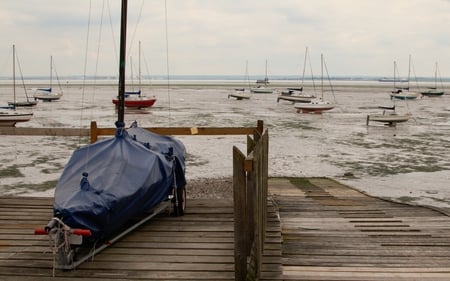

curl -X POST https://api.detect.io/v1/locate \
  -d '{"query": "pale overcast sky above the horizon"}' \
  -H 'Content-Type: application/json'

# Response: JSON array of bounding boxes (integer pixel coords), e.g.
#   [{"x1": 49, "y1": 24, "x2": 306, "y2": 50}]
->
[{"x1": 0, "y1": 0, "x2": 450, "y2": 77}]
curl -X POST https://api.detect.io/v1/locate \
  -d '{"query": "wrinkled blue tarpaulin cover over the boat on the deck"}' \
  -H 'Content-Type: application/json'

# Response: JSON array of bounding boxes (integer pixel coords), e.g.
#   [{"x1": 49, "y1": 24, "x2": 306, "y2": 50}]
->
[{"x1": 53, "y1": 121, "x2": 186, "y2": 242}]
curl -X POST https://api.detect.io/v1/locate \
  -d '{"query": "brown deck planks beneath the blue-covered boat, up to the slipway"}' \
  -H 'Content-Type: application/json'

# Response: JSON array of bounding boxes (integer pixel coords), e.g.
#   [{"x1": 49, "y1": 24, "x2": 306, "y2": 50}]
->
[{"x1": 0, "y1": 197, "x2": 281, "y2": 281}]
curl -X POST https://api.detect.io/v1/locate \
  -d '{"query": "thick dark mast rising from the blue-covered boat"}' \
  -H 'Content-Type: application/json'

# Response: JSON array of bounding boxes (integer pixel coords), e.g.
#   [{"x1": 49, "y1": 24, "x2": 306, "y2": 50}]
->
[{"x1": 117, "y1": 0, "x2": 128, "y2": 124}]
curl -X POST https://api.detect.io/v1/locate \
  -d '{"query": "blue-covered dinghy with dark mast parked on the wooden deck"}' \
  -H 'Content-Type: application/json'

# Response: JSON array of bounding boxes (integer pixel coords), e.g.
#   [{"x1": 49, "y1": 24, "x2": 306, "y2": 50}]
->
[{"x1": 35, "y1": 0, "x2": 186, "y2": 269}]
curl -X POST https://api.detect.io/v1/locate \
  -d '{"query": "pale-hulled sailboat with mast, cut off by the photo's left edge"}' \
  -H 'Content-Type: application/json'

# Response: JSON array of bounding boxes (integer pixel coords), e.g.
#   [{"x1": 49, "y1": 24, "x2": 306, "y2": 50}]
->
[{"x1": 0, "y1": 45, "x2": 33, "y2": 127}]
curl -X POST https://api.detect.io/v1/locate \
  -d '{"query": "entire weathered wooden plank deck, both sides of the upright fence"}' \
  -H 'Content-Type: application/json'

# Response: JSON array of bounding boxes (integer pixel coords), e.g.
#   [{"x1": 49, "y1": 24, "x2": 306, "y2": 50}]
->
[{"x1": 0, "y1": 178, "x2": 450, "y2": 281}]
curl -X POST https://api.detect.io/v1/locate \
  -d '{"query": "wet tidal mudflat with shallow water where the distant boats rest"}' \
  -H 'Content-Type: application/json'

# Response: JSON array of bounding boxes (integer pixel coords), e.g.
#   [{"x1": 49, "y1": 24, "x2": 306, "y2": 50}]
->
[{"x1": 0, "y1": 80, "x2": 450, "y2": 207}]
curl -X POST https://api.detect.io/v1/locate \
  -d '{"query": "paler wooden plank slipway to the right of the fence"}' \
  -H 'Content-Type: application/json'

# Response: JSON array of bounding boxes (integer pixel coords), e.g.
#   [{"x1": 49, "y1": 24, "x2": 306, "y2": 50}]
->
[{"x1": 269, "y1": 178, "x2": 450, "y2": 280}]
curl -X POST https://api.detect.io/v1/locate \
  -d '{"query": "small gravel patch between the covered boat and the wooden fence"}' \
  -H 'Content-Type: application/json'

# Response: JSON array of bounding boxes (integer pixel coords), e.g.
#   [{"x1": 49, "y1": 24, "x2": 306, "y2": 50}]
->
[{"x1": 186, "y1": 177, "x2": 233, "y2": 199}]
